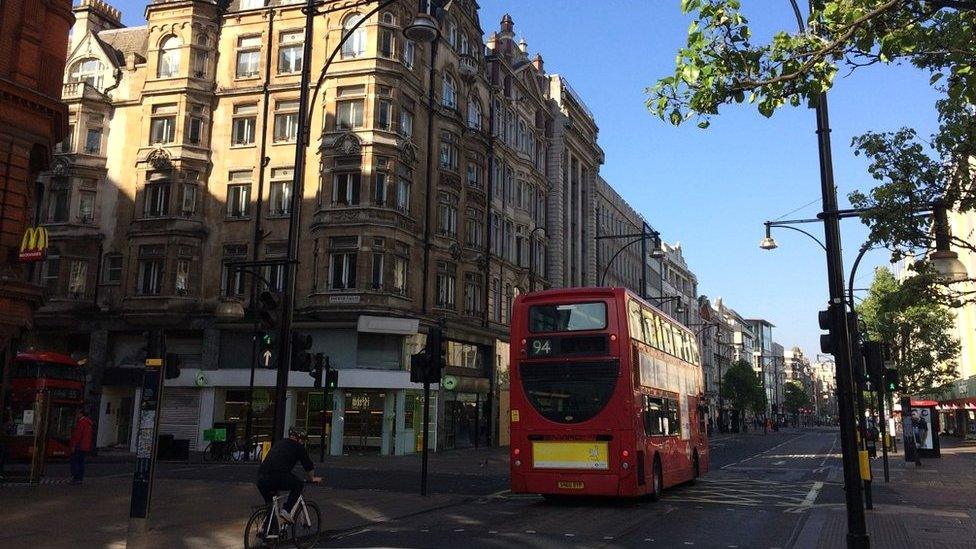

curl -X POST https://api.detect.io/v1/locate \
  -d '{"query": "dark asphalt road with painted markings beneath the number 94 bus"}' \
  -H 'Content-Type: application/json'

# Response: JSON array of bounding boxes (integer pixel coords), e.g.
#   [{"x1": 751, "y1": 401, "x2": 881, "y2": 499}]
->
[{"x1": 320, "y1": 430, "x2": 842, "y2": 549}]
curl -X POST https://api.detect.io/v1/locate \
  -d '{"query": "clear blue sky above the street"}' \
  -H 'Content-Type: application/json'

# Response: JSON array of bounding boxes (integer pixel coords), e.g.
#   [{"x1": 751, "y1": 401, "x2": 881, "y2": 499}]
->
[{"x1": 110, "y1": 0, "x2": 937, "y2": 358}]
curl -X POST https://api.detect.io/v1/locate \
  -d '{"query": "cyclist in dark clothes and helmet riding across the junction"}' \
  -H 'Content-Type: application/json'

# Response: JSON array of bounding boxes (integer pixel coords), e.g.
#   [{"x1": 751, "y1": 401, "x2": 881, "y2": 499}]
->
[{"x1": 257, "y1": 427, "x2": 322, "y2": 522}]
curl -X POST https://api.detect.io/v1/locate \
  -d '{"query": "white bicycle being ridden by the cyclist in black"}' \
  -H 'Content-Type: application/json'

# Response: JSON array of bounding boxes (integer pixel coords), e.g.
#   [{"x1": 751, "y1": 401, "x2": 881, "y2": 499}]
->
[{"x1": 244, "y1": 481, "x2": 322, "y2": 549}]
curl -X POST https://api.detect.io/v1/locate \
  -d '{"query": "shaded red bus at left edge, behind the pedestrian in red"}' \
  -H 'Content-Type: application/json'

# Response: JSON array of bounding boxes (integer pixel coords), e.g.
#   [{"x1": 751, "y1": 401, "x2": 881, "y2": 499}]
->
[{"x1": 7, "y1": 351, "x2": 86, "y2": 460}]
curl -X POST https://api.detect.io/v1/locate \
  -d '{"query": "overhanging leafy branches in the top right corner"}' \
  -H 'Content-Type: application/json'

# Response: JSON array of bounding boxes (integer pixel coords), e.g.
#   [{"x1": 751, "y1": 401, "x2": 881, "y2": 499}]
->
[{"x1": 647, "y1": 0, "x2": 976, "y2": 300}]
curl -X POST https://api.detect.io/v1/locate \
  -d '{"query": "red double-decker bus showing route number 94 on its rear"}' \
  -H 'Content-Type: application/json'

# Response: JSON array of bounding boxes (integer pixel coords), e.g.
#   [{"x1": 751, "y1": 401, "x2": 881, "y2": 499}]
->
[{"x1": 510, "y1": 288, "x2": 708, "y2": 499}]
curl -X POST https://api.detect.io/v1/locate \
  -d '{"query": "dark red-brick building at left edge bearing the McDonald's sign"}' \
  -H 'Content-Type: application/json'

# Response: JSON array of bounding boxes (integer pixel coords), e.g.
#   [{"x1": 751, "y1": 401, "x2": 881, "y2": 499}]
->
[{"x1": 0, "y1": 0, "x2": 73, "y2": 402}]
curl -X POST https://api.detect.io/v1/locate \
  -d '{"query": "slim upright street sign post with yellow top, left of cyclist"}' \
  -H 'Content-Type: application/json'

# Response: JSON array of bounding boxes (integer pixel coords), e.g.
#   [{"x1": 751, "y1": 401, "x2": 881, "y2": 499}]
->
[{"x1": 128, "y1": 330, "x2": 166, "y2": 546}]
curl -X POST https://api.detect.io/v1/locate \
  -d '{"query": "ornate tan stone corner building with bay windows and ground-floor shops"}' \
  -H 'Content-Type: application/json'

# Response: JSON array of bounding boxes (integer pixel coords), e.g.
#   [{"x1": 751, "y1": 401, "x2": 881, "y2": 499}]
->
[{"x1": 31, "y1": 0, "x2": 552, "y2": 454}]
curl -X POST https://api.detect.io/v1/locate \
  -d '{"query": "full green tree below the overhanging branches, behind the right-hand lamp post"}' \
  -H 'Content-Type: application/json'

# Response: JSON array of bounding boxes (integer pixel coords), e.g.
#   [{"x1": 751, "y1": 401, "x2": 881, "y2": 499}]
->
[{"x1": 857, "y1": 268, "x2": 959, "y2": 394}]
